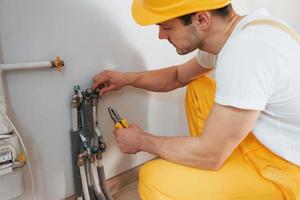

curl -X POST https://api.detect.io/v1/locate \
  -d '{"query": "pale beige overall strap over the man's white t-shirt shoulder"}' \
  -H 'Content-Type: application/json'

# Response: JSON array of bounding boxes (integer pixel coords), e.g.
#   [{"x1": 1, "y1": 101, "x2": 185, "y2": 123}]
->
[{"x1": 242, "y1": 19, "x2": 300, "y2": 45}]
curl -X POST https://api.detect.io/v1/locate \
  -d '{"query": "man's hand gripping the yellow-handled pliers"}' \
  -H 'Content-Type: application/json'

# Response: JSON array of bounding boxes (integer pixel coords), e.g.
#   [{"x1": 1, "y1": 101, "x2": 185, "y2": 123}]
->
[{"x1": 114, "y1": 124, "x2": 145, "y2": 154}]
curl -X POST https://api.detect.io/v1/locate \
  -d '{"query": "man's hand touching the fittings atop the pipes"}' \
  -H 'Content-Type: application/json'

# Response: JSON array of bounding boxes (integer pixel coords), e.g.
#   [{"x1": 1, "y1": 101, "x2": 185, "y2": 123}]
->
[{"x1": 92, "y1": 70, "x2": 126, "y2": 96}]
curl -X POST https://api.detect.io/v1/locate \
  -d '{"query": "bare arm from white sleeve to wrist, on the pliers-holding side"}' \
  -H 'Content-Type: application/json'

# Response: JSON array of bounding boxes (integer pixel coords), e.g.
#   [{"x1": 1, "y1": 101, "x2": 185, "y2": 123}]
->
[{"x1": 139, "y1": 104, "x2": 259, "y2": 170}]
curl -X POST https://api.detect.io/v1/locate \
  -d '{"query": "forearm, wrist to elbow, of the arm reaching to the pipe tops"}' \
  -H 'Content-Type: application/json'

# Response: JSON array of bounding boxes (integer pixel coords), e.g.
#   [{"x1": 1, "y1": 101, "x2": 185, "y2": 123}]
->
[{"x1": 126, "y1": 66, "x2": 185, "y2": 92}]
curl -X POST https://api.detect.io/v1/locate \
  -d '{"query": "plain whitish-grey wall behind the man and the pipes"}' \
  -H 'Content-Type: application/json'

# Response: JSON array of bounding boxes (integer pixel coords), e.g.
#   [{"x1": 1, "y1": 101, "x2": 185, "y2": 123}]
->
[{"x1": 0, "y1": 0, "x2": 299, "y2": 200}]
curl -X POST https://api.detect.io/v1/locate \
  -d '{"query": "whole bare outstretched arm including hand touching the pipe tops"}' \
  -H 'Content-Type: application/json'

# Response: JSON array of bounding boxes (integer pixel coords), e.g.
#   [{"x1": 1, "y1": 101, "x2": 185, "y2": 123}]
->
[{"x1": 92, "y1": 58, "x2": 209, "y2": 95}]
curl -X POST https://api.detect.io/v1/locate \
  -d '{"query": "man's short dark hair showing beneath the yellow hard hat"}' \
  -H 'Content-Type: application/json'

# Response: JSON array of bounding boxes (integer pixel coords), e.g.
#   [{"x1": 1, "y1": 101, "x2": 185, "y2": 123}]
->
[{"x1": 178, "y1": 4, "x2": 233, "y2": 26}]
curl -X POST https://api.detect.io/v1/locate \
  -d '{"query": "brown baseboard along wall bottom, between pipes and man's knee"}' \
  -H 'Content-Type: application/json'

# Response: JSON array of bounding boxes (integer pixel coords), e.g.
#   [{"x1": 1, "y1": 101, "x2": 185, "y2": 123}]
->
[{"x1": 66, "y1": 166, "x2": 140, "y2": 200}]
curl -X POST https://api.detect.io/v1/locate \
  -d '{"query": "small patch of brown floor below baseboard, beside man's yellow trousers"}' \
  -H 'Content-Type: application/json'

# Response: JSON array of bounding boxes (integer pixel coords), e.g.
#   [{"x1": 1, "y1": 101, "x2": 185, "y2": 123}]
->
[{"x1": 113, "y1": 181, "x2": 140, "y2": 200}]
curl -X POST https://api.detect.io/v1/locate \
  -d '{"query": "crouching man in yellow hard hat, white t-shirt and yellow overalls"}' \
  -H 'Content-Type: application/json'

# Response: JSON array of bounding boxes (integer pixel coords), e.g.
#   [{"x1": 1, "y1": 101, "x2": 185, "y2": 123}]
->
[{"x1": 93, "y1": 0, "x2": 300, "y2": 200}]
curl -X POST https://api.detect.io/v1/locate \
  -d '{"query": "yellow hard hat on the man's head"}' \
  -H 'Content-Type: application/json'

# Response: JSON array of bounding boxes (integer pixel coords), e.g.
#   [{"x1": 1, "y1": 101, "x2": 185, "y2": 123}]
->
[{"x1": 131, "y1": 0, "x2": 230, "y2": 26}]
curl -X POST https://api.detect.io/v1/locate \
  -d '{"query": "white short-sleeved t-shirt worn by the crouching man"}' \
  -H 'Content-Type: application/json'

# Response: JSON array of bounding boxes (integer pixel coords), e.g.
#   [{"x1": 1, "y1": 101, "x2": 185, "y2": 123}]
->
[{"x1": 196, "y1": 9, "x2": 300, "y2": 166}]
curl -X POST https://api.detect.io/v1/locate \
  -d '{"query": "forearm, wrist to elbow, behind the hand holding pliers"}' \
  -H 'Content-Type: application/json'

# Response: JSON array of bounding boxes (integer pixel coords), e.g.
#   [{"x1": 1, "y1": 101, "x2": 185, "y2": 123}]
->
[{"x1": 140, "y1": 133, "x2": 219, "y2": 170}]
